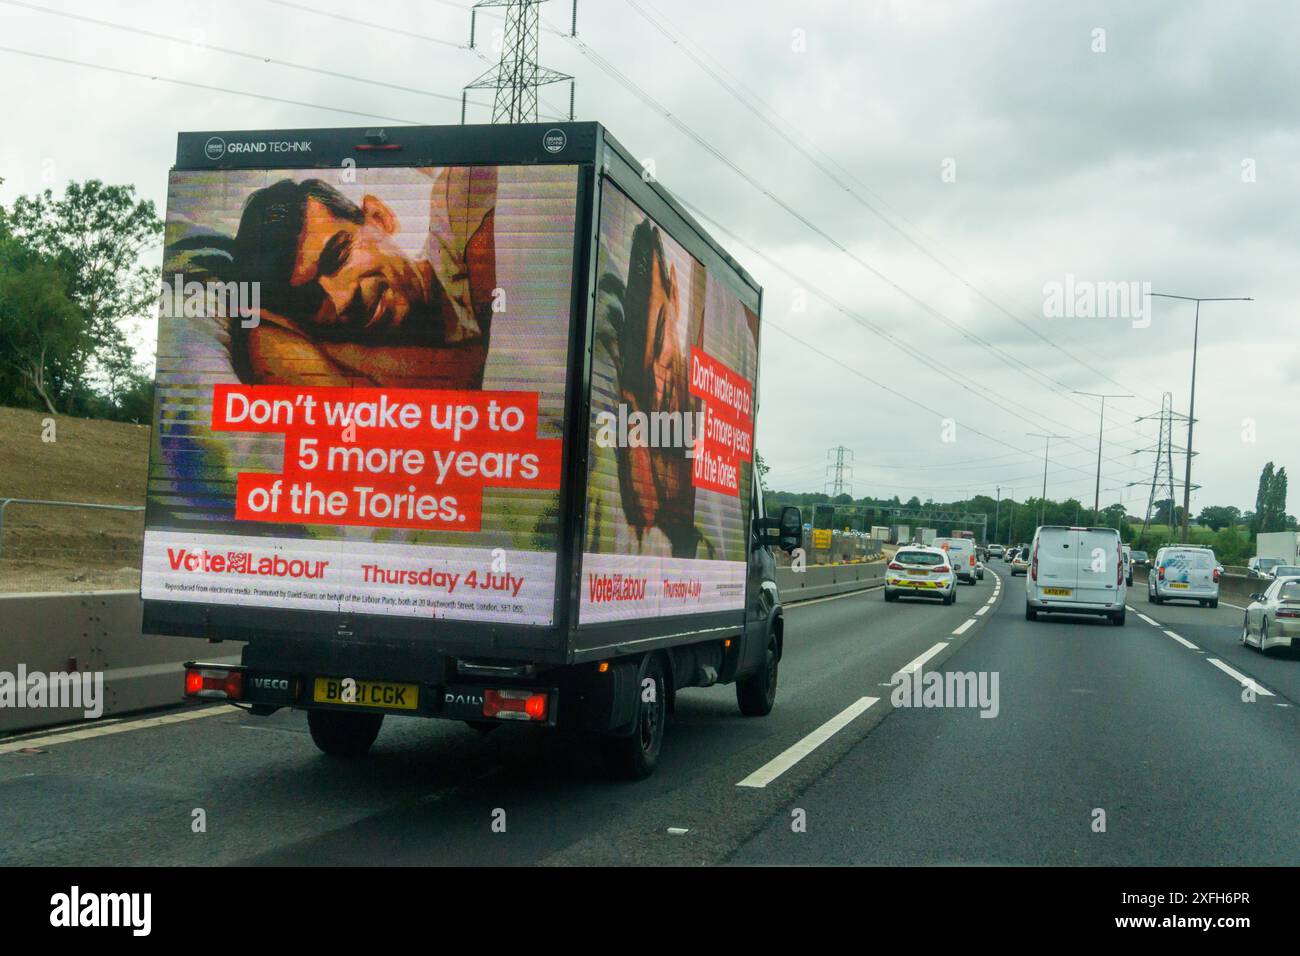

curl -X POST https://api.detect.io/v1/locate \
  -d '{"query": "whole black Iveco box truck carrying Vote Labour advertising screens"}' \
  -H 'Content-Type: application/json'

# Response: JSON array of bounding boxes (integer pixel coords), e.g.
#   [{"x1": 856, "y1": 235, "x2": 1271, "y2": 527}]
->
[{"x1": 140, "y1": 124, "x2": 802, "y2": 778}]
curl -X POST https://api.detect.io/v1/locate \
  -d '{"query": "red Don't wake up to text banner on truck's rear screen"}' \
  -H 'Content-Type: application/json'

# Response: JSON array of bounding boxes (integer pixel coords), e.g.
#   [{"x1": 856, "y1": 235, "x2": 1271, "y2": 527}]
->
[{"x1": 212, "y1": 385, "x2": 562, "y2": 532}]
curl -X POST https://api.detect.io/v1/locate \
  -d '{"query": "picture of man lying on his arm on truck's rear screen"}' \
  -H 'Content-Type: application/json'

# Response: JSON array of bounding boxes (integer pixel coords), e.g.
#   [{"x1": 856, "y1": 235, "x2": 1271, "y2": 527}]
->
[{"x1": 231, "y1": 174, "x2": 495, "y2": 389}]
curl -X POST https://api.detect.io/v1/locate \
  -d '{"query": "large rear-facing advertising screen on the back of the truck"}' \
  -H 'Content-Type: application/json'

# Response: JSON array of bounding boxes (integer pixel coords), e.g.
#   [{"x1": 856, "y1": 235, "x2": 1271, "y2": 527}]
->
[{"x1": 140, "y1": 165, "x2": 577, "y2": 624}]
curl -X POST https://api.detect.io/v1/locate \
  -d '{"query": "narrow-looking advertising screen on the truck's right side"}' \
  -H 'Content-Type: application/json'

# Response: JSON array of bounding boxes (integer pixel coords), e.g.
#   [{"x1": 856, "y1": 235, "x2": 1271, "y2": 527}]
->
[{"x1": 579, "y1": 181, "x2": 758, "y2": 623}]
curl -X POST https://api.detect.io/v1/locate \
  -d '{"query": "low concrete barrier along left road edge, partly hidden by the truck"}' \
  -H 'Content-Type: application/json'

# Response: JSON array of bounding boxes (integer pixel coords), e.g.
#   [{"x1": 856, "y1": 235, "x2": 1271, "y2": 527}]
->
[{"x1": 0, "y1": 562, "x2": 884, "y2": 734}]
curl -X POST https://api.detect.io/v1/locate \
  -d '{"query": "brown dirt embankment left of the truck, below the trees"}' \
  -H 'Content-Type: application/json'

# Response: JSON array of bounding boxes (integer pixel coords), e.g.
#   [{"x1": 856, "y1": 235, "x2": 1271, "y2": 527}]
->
[{"x1": 0, "y1": 407, "x2": 150, "y2": 592}]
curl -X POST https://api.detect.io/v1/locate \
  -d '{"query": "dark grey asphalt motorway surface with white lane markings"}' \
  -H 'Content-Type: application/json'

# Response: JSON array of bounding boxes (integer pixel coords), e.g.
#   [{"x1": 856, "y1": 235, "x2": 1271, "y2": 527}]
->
[{"x1": 0, "y1": 562, "x2": 1300, "y2": 865}]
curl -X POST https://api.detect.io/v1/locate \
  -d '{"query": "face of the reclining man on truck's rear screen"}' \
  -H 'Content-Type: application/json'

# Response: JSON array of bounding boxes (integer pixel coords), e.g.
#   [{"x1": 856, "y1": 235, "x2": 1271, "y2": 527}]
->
[{"x1": 291, "y1": 195, "x2": 432, "y2": 337}]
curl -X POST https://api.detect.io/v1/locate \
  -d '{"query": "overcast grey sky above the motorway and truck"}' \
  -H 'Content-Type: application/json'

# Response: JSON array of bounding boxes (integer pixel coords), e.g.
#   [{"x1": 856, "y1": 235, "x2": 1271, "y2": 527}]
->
[{"x1": 0, "y1": 0, "x2": 1300, "y2": 514}]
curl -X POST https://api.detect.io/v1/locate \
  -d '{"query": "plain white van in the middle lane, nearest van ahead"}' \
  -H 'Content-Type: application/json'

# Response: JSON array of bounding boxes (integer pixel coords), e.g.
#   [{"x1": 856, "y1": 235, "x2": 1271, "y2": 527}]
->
[{"x1": 1024, "y1": 524, "x2": 1127, "y2": 626}]
